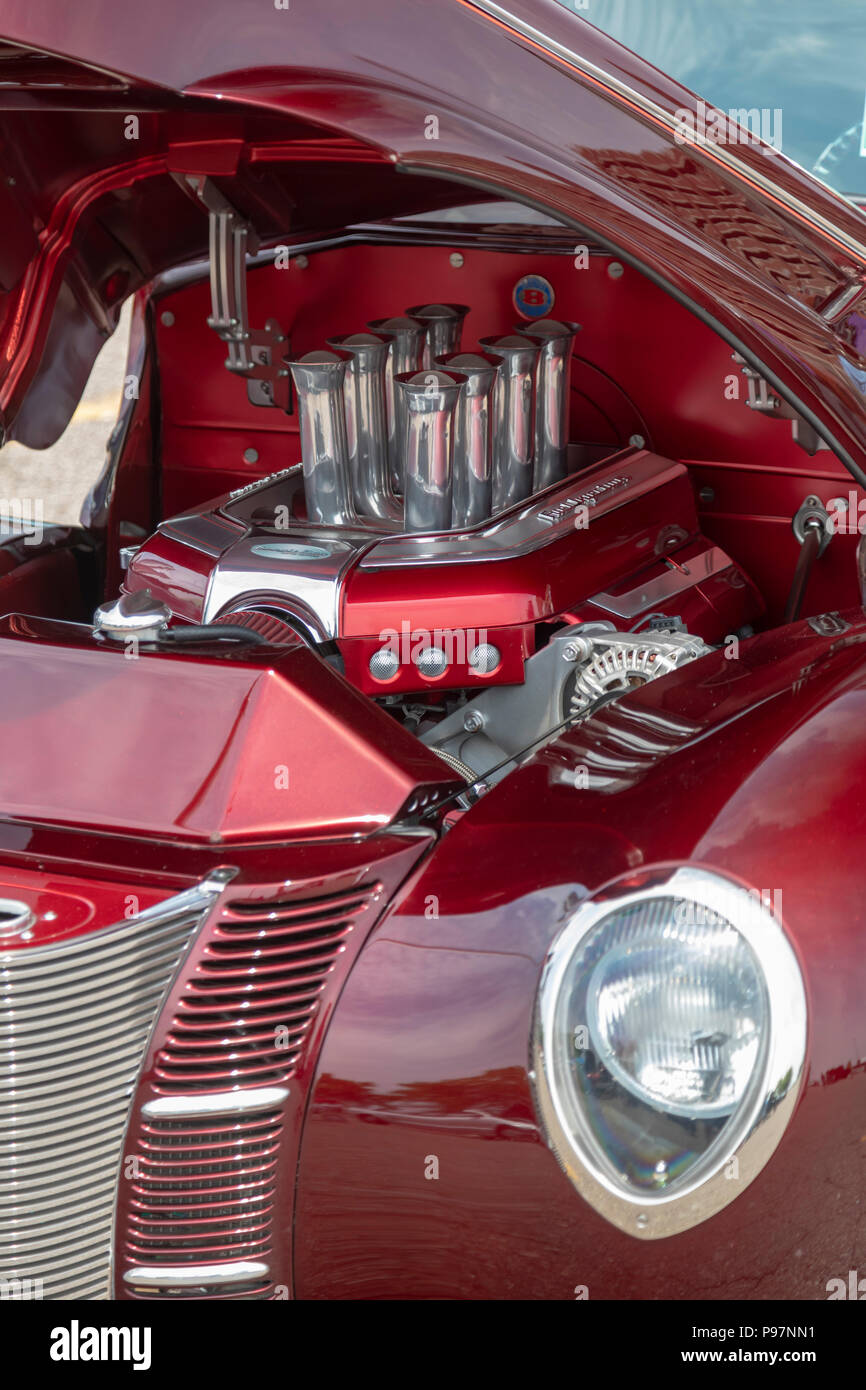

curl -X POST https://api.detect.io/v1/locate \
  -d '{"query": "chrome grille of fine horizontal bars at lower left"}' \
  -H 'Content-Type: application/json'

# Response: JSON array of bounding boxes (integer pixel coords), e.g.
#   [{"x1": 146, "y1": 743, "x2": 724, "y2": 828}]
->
[{"x1": 0, "y1": 872, "x2": 225, "y2": 1300}]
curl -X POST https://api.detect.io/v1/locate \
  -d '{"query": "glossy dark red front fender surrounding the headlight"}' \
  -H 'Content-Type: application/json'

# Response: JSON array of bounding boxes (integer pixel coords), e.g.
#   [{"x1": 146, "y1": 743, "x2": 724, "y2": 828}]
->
[{"x1": 296, "y1": 610, "x2": 866, "y2": 1298}]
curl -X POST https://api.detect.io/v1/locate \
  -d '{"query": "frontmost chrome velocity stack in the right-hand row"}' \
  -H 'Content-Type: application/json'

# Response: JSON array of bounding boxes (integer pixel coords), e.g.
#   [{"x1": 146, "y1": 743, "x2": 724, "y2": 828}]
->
[{"x1": 395, "y1": 368, "x2": 466, "y2": 531}]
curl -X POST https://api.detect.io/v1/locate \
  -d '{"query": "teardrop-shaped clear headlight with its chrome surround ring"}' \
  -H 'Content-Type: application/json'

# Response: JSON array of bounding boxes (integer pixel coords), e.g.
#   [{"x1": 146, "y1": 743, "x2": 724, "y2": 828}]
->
[{"x1": 532, "y1": 869, "x2": 806, "y2": 1237}]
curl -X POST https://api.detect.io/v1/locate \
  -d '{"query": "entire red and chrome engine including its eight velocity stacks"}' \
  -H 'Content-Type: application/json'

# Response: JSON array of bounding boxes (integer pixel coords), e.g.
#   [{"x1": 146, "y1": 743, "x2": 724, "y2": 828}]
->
[{"x1": 124, "y1": 304, "x2": 763, "y2": 794}]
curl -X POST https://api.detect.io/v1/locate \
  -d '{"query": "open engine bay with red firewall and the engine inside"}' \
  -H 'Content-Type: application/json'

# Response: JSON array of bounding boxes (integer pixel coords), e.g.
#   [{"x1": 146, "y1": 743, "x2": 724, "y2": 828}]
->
[{"x1": 37, "y1": 181, "x2": 856, "y2": 808}]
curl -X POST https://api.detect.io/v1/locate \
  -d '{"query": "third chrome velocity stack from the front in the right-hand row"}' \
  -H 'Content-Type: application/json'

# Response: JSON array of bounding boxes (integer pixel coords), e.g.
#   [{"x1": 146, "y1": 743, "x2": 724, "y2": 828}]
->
[{"x1": 478, "y1": 334, "x2": 541, "y2": 513}]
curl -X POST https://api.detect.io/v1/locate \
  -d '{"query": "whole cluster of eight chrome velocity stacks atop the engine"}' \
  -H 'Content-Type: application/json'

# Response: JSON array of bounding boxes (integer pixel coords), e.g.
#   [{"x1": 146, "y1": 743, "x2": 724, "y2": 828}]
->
[{"x1": 288, "y1": 304, "x2": 578, "y2": 532}]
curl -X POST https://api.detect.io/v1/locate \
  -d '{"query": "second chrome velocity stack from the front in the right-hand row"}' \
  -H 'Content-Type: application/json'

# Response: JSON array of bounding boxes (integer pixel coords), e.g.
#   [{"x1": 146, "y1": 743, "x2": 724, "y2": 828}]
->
[{"x1": 435, "y1": 352, "x2": 499, "y2": 528}]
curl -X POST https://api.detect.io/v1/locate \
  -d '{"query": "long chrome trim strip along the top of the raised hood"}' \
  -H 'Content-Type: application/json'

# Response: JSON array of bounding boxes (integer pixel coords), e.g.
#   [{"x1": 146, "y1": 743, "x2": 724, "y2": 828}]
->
[{"x1": 463, "y1": 0, "x2": 866, "y2": 264}]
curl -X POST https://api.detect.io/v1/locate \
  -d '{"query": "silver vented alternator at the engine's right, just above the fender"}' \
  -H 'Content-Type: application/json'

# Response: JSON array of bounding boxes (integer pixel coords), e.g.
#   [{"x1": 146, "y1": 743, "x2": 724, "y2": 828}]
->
[{"x1": 569, "y1": 631, "x2": 710, "y2": 719}]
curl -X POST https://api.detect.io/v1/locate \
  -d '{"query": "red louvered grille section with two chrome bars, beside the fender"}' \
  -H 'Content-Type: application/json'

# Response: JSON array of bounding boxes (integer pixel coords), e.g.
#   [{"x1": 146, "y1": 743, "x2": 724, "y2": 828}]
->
[{"x1": 122, "y1": 876, "x2": 384, "y2": 1298}]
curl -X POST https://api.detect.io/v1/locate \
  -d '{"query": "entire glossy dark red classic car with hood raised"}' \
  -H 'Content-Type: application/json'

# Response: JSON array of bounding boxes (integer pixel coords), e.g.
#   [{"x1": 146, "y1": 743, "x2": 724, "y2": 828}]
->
[{"x1": 0, "y1": 0, "x2": 866, "y2": 1300}]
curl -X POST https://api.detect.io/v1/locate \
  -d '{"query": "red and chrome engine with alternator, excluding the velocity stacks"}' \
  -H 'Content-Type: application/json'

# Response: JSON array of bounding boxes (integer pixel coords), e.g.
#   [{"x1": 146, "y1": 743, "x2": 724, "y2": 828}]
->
[{"x1": 125, "y1": 428, "x2": 763, "y2": 795}]
